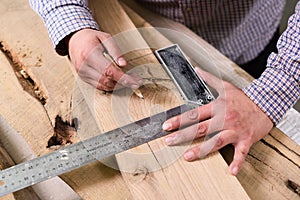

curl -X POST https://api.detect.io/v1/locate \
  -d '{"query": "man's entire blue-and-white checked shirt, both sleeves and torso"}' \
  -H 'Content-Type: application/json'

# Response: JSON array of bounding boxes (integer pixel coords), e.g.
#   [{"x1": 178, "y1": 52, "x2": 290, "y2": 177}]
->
[{"x1": 30, "y1": 0, "x2": 300, "y2": 124}]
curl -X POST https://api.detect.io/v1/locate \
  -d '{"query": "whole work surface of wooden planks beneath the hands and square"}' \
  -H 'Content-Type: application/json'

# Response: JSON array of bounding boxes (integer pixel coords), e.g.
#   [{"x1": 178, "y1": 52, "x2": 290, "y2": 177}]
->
[{"x1": 0, "y1": 0, "x2": 300, "y2": 200}]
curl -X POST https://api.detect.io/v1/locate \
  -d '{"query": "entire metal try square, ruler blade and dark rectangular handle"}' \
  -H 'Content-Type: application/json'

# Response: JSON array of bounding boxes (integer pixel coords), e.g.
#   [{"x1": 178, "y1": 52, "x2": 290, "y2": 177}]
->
[{"x1": 0, "y1": 45, "x2": 213, "y2": 196}]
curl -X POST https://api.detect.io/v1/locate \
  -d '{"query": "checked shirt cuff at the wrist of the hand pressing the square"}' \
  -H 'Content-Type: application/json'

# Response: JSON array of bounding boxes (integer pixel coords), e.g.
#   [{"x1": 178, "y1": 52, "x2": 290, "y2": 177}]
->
[{"x1": 243, "y1": 68, "x2": 300, "y2": 125}]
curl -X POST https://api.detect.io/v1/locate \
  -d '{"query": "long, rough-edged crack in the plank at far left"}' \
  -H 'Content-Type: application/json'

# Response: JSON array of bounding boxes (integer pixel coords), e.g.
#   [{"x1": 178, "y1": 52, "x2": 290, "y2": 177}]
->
[{"x1": 0, "y1": 41, "x2": 48, "y2": 105}]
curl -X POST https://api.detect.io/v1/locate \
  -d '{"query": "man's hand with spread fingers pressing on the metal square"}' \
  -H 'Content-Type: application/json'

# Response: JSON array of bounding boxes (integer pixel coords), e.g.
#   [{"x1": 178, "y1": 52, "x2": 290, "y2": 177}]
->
[{"x1": 163, "y1": 68, "x2": 273, "y2": 175}]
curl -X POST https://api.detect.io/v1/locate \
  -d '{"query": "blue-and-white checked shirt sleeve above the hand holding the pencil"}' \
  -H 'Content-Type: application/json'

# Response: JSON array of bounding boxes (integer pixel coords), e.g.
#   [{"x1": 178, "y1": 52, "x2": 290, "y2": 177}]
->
[{"x1": 30, "y1": 0, "x2": 99, "y2": 55}]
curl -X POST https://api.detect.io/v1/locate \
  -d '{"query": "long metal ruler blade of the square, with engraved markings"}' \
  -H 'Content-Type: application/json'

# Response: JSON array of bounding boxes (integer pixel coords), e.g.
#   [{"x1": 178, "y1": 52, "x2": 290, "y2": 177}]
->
[{"x1": 0, "y1": 104, "x2": 197, "y2": 196}]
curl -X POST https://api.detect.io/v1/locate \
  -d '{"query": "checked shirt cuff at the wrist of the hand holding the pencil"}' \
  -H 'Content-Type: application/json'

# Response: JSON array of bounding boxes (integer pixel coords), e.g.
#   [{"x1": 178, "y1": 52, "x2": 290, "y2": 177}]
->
[{"x1": 45, "y1": 5, "x2": 99, "y2": 55}]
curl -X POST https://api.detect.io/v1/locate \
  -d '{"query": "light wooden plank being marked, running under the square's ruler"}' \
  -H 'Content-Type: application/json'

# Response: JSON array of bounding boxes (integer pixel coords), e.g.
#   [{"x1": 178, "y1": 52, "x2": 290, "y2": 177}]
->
[{"x1": 89, "y1": 1, "x2": 248, "y2": 199}]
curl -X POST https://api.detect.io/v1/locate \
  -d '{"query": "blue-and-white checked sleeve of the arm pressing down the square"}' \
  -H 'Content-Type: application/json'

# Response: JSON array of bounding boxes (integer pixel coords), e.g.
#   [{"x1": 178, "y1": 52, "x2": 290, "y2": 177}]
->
[{"x1": 243, "y1": 2, "x2": 300, "y2": 124}]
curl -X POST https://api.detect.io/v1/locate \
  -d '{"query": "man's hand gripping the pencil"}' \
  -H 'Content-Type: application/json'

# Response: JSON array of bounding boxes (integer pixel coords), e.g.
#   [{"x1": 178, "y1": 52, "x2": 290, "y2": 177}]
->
[{"x1": 68, "y1": 29, "x2": 142, "y2": 91}]
